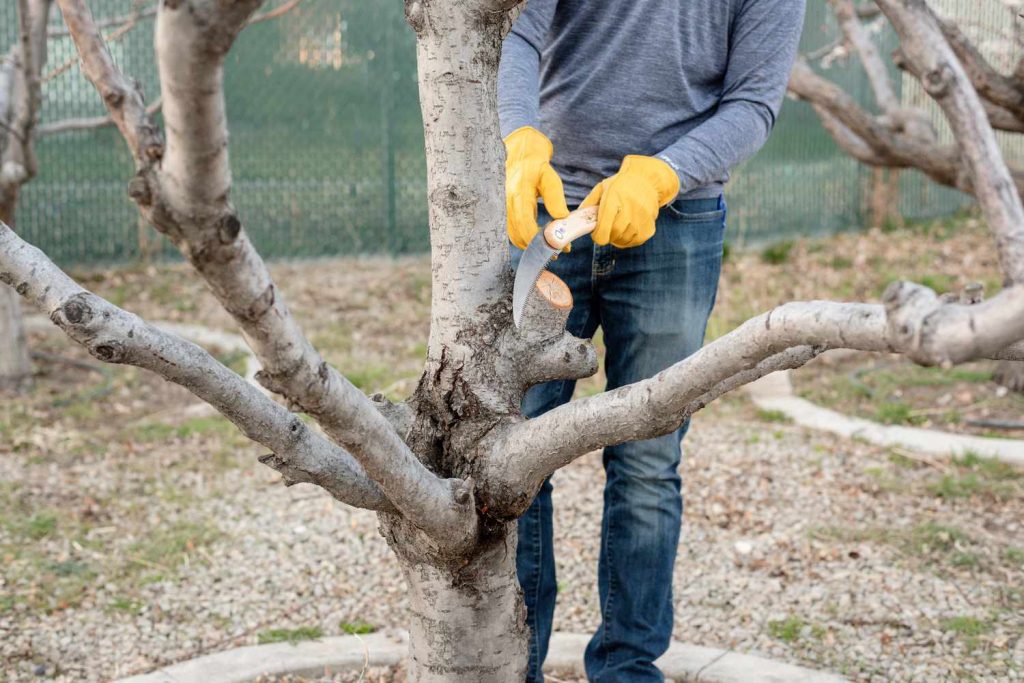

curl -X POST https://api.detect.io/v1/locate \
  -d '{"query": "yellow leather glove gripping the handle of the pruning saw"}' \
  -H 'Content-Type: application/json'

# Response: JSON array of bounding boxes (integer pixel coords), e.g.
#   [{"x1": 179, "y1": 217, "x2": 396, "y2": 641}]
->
[{"x1": 580, "y1": 155, "x2": 679, "y2": 249}]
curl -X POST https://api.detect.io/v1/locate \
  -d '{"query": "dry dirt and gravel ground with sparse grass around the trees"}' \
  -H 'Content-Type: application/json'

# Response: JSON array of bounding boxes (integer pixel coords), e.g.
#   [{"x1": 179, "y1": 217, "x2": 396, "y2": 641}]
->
[{"x1": 0, "y1": 220, "x2": 1024, "y2": 681}]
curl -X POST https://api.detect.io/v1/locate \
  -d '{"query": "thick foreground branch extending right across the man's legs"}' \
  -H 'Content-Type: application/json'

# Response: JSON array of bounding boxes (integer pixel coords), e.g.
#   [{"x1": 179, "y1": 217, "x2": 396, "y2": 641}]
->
[{"x1": 482, "y1": 283, "x2": 1024, "y2": 514}]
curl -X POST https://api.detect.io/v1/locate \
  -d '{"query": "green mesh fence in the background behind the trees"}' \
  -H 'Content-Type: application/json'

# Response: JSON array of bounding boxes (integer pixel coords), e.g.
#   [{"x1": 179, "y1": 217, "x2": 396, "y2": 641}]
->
[{"x1": 0, "y1": 0, "x2": 1007, "y2": 265}]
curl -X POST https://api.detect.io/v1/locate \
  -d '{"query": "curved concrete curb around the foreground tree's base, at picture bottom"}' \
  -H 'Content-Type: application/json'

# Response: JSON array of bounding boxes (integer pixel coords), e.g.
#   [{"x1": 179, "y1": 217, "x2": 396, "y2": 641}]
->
[{"x1": 118, "y1": 631, "x2": 846, "y2": 683}]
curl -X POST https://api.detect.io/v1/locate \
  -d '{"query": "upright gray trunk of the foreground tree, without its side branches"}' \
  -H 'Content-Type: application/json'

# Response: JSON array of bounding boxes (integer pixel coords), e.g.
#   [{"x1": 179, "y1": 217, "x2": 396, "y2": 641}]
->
[{"x1": 382, "y1": 0, "x2": 548, "y2": 683}]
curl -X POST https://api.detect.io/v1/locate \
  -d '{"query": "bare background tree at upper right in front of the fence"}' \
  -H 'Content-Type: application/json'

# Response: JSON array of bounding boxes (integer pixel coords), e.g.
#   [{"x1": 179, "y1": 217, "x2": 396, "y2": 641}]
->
[{"x1": 790, "y1": 0, "x2": 1024, "y2": 391}]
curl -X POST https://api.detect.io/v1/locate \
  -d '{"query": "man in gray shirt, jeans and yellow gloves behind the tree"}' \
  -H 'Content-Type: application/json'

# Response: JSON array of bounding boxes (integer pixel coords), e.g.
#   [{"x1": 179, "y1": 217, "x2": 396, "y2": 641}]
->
[{"x1": 499, "y1": 0, "x2": 804, "y2": 683}]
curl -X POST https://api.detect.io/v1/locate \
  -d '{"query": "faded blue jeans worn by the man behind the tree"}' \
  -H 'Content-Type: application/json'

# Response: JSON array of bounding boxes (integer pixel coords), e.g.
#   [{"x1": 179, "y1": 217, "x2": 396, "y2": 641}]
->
[{"x1": 513, "y1": 198, "x2": 725, "y2": 683}]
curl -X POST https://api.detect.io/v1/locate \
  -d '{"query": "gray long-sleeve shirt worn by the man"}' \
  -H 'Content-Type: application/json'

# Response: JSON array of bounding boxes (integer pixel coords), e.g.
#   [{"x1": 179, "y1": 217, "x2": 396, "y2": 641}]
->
[{"x1": 498, "y1": 0, "x2": 805, "y2": 204}]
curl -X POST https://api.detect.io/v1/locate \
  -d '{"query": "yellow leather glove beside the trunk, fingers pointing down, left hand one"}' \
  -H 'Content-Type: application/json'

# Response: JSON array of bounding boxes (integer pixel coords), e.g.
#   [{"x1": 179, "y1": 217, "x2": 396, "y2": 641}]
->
[{"x1": 505, "y1": 126, "x2": 569, "y2": 249}]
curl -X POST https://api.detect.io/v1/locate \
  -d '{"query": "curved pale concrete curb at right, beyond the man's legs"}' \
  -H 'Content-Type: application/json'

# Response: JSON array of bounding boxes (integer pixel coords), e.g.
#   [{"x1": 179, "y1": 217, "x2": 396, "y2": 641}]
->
[{"x1": 746, "y1": 370, "x2": 1024, "y2": 466}]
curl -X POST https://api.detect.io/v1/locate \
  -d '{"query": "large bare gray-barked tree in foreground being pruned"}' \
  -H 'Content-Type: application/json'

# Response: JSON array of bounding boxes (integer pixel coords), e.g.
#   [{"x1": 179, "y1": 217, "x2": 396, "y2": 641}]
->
[{"x1": 0, "y1": 0, "x2": 1024, "y2": 683}]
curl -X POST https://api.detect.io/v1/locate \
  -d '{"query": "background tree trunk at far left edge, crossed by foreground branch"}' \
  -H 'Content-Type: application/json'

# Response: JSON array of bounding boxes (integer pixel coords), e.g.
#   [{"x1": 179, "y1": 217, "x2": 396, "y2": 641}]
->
[{"x1": 0, "y1": 0, "x2": 50, "y2": 389}]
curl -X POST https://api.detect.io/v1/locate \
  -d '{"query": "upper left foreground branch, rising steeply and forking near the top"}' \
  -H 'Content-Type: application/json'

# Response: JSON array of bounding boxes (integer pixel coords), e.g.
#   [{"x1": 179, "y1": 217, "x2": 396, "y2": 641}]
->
[{"x1": 58, "y1": 0, "x2": 476, "y2": 548}]
